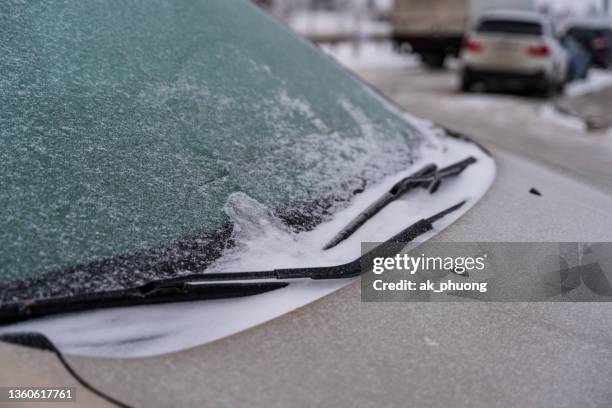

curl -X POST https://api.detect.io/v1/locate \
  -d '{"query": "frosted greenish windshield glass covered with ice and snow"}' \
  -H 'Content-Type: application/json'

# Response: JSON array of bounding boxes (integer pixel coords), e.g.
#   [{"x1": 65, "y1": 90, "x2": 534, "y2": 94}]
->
[{"x1": 0, "y1": 0, "x2": 425, "y2": 301}]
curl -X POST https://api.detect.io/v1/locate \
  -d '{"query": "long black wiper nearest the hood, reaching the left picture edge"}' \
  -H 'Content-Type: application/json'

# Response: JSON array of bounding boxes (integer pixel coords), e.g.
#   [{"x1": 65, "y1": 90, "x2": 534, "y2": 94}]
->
[{"x1": 0, "y1": 202, "x2": 465, "y2": 324}]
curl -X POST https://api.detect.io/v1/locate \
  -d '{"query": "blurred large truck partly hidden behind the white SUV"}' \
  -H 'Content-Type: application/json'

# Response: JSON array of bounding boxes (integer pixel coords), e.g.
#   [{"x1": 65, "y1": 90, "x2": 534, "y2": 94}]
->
[{"x1": 391, "y1": 0, "x2": 534, "y2": 68}]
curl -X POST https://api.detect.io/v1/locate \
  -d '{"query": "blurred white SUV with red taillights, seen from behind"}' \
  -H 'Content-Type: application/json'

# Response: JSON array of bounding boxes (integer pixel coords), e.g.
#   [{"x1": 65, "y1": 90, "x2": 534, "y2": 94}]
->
[{"x1": 461, "y1": 11, "x2": 568, "y2": 93}]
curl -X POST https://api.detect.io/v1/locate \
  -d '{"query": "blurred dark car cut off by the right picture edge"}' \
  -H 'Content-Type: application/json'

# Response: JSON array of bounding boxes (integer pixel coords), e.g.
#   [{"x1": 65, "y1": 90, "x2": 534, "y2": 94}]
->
[{"x1": 565, "y1": 18, "x2": 612, "y2": 68}]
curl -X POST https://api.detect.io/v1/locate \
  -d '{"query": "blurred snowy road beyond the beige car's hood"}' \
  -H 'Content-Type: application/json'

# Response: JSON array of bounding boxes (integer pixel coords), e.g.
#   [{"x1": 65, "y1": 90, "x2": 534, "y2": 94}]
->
[{"x1": 356, "y1": 62, "x2": 612, "y2": 193}]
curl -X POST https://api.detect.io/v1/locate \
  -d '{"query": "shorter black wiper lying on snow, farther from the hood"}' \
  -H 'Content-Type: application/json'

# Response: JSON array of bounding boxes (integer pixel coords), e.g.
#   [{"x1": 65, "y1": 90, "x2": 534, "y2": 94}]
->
[{"x1": 323, "y1": 157, "x2": 476, "y2": 250}]
